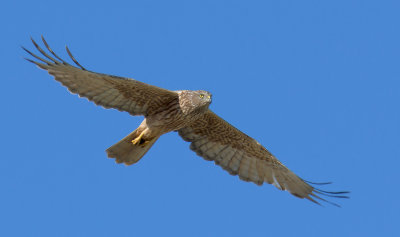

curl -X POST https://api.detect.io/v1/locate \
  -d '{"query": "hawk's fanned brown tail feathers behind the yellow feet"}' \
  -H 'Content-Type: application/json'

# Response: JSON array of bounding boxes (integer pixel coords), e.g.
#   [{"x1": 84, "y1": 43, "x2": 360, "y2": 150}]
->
[{"x1": 106, "y1": 130, "x2": 159, "y2": 165}]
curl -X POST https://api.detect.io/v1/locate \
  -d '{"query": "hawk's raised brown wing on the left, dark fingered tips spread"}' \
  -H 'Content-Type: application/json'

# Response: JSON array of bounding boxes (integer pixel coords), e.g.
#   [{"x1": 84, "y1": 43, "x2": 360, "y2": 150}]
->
[{"x1": 23, "y1": 36, "x2": 178, "y2": 116}]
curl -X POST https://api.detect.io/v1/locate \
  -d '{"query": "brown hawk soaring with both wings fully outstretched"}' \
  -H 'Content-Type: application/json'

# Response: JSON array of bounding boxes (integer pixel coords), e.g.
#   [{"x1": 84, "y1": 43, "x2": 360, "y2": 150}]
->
[{"x1": 22, "y1": 36, "x2": 348, "y2": 206}]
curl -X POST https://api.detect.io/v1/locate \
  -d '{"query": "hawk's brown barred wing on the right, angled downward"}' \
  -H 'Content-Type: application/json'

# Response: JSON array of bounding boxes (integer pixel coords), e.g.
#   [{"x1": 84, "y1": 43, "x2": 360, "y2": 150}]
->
[{"x1": 178, "y1": 111, "x2": 348, "y2": 205}]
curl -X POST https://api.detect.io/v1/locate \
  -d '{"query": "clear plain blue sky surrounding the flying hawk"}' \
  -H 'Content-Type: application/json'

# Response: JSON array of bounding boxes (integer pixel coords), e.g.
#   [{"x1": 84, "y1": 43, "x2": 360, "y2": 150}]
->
[{"x1": 0, "y1": 0, "x2": 400, "y2": 236}]
